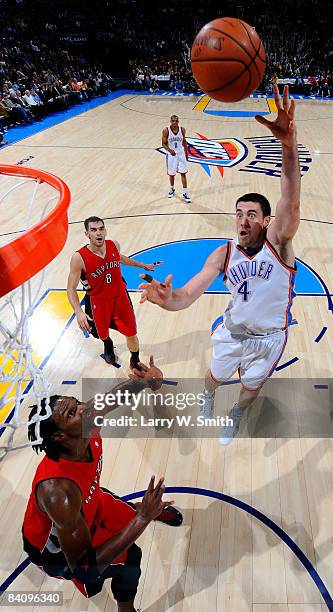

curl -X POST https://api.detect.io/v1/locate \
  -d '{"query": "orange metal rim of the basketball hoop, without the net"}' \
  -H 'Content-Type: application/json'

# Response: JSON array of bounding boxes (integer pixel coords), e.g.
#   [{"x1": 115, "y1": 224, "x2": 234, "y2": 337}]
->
[{"x1": 0, "y1": 164, "x2": 71, "y2": 297}]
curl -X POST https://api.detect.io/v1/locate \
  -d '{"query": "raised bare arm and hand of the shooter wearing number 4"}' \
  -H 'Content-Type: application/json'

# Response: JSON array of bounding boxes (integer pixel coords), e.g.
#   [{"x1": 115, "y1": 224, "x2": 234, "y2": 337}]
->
[{"x1": 256, "y1": 85, "x2": 301, "y2": 245}]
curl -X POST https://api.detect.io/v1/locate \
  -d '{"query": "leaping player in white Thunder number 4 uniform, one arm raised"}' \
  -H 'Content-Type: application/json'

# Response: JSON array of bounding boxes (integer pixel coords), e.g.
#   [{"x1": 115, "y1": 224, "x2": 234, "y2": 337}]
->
[{"x1": 140, "y1": 85, "x2": 301, "y2": 444}]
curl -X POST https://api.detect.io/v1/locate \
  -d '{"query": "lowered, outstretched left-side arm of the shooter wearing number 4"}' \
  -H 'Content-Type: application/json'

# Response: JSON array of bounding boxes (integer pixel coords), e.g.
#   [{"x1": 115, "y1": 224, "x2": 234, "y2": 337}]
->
[{"x1": 139, "y1": 244, "x2": 227, "y2": 310}]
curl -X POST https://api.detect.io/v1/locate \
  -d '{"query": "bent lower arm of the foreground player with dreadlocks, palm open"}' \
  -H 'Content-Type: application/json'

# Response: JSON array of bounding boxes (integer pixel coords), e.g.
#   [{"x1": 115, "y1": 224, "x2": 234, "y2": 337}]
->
[{"x1": 37, "y1": 476, "x2": 173, "y2": 582}]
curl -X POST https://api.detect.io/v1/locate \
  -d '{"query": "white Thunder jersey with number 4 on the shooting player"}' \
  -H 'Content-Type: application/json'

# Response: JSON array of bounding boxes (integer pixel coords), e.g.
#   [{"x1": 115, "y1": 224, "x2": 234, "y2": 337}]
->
[{"x1": 224, "y1": 240, "x2": 296, "y2": 335}]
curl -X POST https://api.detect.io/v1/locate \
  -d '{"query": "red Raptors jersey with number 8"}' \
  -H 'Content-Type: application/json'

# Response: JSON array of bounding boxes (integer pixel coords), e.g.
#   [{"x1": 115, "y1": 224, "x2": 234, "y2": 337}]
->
[{"x1": 78, "y1": 240, "x2": 126, "y2": 300}]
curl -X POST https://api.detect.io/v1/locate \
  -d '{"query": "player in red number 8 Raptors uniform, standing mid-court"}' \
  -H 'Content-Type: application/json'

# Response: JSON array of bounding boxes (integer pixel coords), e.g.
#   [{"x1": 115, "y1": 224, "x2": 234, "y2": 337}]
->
[{"x1": 67, "y1": 217, "x2": 161, "y2": 369}]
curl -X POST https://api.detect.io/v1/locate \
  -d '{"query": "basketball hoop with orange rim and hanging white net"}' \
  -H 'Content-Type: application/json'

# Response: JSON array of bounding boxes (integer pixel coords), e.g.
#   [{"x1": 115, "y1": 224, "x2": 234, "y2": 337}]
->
[{"x1": 0, "y1": 164, "x2": 70, "y2": 459}]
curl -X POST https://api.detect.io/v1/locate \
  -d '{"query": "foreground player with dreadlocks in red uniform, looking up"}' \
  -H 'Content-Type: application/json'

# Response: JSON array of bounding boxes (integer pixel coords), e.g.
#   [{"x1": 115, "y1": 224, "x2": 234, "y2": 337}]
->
[{"x1": 22, "y1": 357, "x2": 182, "y2": 612}]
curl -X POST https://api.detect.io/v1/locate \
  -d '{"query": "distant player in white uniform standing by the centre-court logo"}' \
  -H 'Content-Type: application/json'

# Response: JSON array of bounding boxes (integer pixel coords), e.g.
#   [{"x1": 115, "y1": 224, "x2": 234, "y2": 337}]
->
[{"x1": 162, "y1": 115, "x2": 191, "y2": 204}]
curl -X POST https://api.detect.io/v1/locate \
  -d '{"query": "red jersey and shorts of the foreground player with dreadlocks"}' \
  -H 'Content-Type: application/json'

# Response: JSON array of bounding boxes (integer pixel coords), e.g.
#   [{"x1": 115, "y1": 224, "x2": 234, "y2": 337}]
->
[{"x1": 23, "y1": 438, "x2": 135, "y2": 564}]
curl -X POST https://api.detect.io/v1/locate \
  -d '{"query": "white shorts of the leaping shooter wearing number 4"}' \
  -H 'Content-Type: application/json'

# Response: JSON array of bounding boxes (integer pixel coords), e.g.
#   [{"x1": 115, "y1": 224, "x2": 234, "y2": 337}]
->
[{"x1": 210, "y1": 321, "x2": 287, "y2": 390}]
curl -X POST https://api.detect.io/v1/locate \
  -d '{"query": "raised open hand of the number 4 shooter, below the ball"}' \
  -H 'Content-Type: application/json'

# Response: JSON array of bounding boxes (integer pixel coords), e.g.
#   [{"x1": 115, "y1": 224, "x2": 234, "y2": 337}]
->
[{"x1": 255, "y1": 84, "x2": 296, "y2": 147}]
